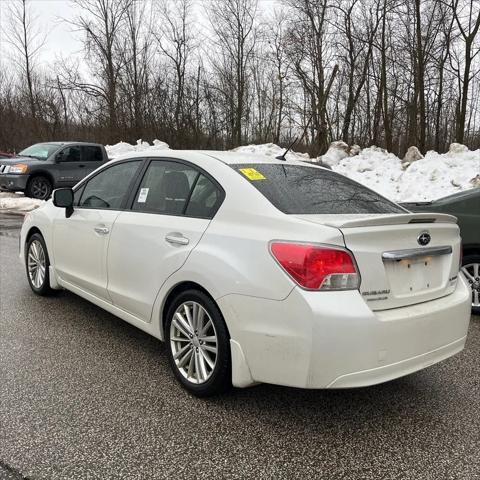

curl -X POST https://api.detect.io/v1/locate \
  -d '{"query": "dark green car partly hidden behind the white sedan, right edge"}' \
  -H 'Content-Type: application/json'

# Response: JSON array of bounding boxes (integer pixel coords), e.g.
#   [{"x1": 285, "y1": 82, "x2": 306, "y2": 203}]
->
[{"x1": 402, "y1": 187, "x2": 480, "y2": 315}]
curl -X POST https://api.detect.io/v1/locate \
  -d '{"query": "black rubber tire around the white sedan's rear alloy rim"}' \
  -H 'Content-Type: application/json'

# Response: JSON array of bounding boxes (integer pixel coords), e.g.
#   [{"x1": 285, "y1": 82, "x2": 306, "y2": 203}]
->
[{"x1": 165, "y1": 290, "x2": 232, "y2": 397}]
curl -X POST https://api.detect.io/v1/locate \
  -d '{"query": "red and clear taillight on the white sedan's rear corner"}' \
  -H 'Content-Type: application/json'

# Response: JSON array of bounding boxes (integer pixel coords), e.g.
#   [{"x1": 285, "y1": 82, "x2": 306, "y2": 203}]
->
[{"x1": 270, "y1": 242, "x2": 360, "y2": 290}]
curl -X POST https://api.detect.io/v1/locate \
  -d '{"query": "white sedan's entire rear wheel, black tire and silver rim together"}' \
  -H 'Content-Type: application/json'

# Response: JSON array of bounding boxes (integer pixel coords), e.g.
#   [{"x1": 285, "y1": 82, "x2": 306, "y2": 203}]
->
[{"x1": 165, "y1": 290, "x2": 231, "y2": 397}]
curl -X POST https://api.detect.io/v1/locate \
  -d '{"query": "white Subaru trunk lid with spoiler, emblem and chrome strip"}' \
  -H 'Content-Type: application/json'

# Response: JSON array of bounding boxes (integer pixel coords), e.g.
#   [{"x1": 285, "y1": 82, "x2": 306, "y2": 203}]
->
[{"x1": 297, "y1": 213, "x2": 460, "y2": 310}]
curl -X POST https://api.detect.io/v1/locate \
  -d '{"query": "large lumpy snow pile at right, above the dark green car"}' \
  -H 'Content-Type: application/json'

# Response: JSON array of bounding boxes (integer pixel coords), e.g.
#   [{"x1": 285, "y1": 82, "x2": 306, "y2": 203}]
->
[{"x1": 323, "y1": 144, "x2": 480, "y2": 202}]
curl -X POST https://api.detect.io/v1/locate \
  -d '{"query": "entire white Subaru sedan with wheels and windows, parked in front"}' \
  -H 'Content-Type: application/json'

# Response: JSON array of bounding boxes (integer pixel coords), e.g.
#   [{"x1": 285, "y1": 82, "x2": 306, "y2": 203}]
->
[{"x1": 20, "y1": 151, "x2": 471, "y2": 396}]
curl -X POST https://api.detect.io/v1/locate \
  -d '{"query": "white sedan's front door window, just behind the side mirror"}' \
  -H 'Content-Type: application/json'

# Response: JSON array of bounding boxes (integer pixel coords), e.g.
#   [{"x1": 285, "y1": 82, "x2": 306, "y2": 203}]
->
[{"x1": 78, "y1": 160, "x2": 141, "y2": 210}]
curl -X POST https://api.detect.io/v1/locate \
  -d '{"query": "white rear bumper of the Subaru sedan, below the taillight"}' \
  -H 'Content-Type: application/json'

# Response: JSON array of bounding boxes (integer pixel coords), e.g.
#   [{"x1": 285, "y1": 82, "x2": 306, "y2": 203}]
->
[{"x1": 218, "y1": 276, "x2": 471, "y2": 388}]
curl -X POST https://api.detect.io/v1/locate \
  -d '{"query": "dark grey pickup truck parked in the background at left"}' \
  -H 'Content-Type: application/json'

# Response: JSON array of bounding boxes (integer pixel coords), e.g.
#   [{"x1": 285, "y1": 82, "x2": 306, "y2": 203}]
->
[{"x1": 0, "y1": 142, "x2": 108, "y2": 200}]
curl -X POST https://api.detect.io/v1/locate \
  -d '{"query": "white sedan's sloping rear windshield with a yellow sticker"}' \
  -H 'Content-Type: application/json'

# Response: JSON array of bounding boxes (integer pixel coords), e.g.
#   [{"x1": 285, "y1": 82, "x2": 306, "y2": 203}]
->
[{"x1": 231, "y1": 163, "x2": 405, "y2": 214}]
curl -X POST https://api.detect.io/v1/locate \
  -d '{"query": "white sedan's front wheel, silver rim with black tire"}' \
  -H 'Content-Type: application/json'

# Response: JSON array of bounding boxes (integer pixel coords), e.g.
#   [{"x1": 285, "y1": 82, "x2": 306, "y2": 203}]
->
[{"x1": 25, "y1": 233, "x2": 53, "y2": 296}]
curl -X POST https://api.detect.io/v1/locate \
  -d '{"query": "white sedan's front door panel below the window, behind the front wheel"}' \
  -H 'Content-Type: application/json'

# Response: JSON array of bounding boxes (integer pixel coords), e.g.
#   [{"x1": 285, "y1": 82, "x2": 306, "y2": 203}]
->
[{"x1": 53, "y1": 209, "x2": 119, "y2": 301}]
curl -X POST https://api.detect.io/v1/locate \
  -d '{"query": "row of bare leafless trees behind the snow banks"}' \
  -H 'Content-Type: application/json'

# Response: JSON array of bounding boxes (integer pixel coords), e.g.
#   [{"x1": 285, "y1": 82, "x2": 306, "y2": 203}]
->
[{"x1": 0, "y1": 0, "x2": 480, "y2": 155}]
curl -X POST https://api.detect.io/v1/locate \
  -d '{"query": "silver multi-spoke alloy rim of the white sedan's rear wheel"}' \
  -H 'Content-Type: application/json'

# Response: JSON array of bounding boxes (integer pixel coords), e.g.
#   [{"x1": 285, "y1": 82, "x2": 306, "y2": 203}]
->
[{"x1": 170, "y1": 301, "x2": 218, "y2": 384}]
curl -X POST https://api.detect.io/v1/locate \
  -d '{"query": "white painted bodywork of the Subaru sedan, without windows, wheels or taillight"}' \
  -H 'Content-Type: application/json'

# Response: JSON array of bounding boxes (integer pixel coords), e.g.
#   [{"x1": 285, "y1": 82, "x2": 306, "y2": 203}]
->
[{"x1": 20, "y1": 151, "x2": 471, "y2": 388}]
